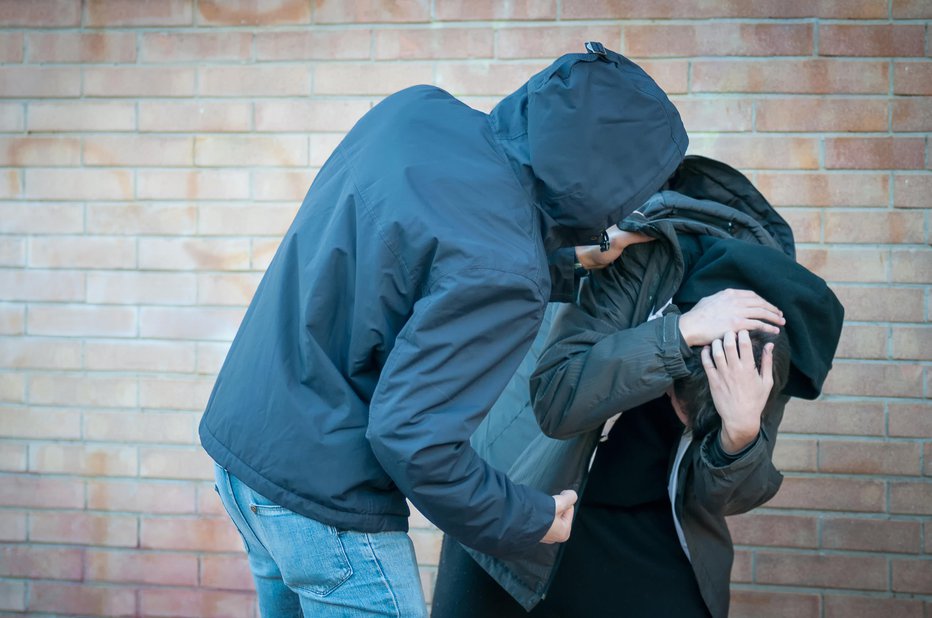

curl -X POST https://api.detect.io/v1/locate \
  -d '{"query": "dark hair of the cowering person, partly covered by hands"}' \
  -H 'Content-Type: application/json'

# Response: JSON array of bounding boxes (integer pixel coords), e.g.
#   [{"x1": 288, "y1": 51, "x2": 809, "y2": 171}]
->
[{"x1": 673, "y1": 328, "x2": 790, "y2": 440}]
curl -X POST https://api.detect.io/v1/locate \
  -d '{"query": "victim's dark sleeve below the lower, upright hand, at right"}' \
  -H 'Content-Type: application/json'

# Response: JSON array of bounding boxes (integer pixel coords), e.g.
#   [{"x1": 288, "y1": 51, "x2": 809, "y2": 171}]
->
[{"x1": 686, "y1": 395, "x2": 789, "y2": 516}]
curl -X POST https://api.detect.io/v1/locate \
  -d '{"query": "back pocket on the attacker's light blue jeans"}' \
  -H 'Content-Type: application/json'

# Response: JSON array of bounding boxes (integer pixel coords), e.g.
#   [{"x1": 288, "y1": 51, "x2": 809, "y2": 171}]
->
[{"x1": 249, "y1": 490, "x2": 353, "y2": 597}]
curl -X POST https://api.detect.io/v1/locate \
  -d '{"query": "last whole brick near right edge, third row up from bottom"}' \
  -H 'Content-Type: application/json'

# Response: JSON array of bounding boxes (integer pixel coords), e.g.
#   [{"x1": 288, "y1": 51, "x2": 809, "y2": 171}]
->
[{"x1": 822, "y1": 517, "x2": 920, "y2": 554}]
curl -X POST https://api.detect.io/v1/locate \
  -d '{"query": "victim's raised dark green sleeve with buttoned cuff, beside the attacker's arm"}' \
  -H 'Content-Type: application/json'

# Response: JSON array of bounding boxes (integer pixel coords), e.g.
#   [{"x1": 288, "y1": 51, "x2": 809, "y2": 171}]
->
[{"x1": 531, "y1": 272, "x2": 692, "y2": 439}]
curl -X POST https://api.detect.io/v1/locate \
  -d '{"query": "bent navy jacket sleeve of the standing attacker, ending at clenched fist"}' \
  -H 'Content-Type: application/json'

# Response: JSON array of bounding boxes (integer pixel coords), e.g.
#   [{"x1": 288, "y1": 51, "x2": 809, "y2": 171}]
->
[{"x1": 366, "y1": 268, "x2": 555, "y2": 555}]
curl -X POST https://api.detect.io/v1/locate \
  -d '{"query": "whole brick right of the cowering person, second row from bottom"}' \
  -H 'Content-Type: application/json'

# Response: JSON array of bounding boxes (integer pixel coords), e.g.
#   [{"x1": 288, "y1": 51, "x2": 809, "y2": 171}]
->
[{"x1": 755, "y1": 552, "x2": 887, "y2": 590}]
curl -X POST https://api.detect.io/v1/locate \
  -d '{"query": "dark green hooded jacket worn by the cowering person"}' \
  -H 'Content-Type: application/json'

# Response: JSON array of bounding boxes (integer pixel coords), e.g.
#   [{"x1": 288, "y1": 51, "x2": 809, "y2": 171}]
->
[{"x1": 470, "y1": 157, "x2": 794, "y2": 616}]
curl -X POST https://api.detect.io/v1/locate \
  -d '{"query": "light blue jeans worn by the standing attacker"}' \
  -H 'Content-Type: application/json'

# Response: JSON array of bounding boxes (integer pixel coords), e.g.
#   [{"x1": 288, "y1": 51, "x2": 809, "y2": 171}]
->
[{"x1": 215, "y1": 465, "x2": 427, "y2": 618}]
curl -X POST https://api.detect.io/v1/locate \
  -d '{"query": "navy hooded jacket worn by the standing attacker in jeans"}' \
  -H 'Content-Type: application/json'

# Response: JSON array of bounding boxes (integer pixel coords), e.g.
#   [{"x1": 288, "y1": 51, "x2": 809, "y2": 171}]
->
[{"x1": 200, "y1": 43, "x2": 687, "y2": 554}]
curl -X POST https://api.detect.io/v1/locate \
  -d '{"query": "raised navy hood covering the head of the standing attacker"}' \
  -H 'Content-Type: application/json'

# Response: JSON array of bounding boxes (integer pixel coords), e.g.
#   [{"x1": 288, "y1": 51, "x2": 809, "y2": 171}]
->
[{"x1": 491, "y1": 43, "x2": 688, "y2": 250}]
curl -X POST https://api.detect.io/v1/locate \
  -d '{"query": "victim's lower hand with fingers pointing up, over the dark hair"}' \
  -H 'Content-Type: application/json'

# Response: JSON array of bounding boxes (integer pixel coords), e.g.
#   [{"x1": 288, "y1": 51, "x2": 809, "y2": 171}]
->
[{"x1": 702, "y1": 330, "x2": 773, "y2": 453}]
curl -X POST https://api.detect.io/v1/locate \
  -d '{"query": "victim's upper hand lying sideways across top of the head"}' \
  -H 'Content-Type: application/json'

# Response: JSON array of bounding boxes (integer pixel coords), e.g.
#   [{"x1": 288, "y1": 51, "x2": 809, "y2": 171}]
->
[{"x1": 680, "y1": 290, "x2": 786, "y2": 347}]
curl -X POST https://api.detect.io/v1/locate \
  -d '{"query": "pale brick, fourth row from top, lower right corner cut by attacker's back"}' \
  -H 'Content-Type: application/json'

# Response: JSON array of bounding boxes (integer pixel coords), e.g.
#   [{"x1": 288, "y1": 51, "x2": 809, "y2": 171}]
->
[{"x1": 256, "y1": 100, "x2": 372, "y2": 132}]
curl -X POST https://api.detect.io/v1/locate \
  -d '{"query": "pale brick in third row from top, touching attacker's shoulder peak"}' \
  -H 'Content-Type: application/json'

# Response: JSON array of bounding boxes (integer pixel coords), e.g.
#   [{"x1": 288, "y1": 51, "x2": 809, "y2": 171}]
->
[{"x1": 314, "y1": 62, "x2": 434, "y2": 94}]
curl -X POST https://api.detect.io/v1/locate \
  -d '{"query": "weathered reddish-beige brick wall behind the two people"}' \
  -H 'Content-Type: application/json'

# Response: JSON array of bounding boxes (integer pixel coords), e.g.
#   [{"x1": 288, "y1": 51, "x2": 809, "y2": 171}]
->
[{"x1": 0, "y1": 0, "x2": 932, "y2": 618}]
